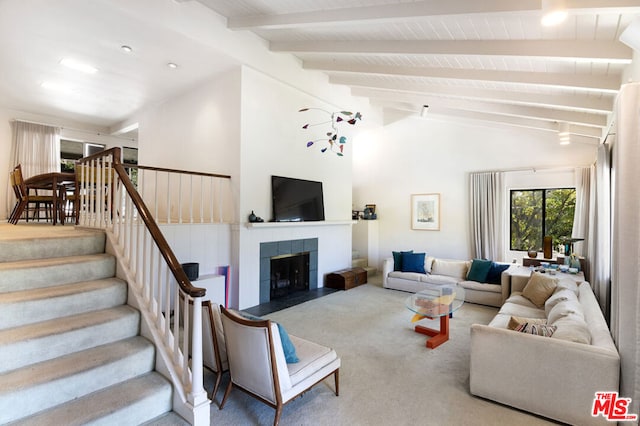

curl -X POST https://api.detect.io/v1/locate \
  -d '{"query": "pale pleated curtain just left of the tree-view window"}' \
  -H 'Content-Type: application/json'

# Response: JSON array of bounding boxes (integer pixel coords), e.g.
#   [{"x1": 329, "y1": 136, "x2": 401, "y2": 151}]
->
[{"x1": 469, "y1": 172, "x2": 504, "y2": 261}]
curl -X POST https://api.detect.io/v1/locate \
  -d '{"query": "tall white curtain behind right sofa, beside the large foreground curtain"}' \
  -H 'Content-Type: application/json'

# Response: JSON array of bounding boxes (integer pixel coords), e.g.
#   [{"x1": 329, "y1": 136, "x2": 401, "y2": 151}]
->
[{"x1": 589, "y1": 143, "x2": 615, "y2": 322}]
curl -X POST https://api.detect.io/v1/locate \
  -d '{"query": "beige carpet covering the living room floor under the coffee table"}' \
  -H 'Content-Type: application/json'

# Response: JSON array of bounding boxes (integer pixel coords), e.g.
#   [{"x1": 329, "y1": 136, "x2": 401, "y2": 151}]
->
[{"x1": 205, "y1": 278, "x2": 553, "y2": 425}]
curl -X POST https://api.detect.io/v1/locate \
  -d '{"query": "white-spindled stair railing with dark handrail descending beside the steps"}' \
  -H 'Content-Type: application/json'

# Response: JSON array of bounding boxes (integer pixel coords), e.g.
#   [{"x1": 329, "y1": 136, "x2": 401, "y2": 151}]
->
[{"x1": 76, "y1": 148, "x2": 210, "y2": 425}]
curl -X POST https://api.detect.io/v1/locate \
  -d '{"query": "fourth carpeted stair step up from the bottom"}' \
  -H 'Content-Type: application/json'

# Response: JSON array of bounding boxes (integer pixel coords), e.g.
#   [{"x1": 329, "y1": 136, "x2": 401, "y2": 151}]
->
[{"x1": 0, "y1": 278, "x2": 127, "y2": 332}]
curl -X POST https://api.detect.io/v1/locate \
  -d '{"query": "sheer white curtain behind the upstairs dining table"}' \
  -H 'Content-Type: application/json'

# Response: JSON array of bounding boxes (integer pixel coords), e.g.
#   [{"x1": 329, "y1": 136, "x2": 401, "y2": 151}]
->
[{"x1": 7, "y1": 120, "x2": 60, "y2": 216}]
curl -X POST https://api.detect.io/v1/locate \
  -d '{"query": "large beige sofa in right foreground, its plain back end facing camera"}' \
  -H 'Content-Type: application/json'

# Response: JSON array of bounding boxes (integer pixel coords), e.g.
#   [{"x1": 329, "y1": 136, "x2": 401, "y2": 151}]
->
[{"x1": 470, "y1": 275, "x2": 620, "y2": 425}]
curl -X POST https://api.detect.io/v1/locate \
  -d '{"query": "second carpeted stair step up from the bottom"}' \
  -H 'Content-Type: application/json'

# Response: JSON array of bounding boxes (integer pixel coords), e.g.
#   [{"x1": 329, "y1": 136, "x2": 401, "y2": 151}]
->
[{"x1": 0, "y1": 336, "x2": 155, "y2": 423}]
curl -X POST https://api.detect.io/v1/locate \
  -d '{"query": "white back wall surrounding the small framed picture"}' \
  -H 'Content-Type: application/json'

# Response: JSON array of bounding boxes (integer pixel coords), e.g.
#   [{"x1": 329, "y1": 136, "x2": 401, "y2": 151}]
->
[{"x1": 353, "y1": 117, "x2": 596, "y2": 267}]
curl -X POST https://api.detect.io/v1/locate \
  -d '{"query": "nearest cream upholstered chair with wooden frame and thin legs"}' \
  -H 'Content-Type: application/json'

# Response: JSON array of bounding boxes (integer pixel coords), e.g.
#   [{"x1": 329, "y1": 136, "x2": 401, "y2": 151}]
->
[{"x1": 220, "y1": 307, "x2": 340, "y2": 426}]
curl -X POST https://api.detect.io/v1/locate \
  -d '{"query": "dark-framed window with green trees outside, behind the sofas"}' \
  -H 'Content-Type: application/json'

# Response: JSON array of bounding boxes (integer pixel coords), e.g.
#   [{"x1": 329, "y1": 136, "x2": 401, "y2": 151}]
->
[{"x1": 510, "y1": 188, "x2": 576, "y2": 251}]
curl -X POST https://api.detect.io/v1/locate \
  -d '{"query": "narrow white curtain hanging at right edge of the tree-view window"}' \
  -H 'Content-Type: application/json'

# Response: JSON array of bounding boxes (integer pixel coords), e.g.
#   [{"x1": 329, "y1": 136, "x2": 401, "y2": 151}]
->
[{"x1": 571, "y1": 167, "x2": 595, "y2": 282}]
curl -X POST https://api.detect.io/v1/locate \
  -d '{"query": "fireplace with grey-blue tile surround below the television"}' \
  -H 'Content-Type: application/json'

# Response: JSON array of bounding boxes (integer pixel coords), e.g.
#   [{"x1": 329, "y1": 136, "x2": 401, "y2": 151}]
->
[{"x1": 260, "y1": 238, "x2": 318, "y2": 303}]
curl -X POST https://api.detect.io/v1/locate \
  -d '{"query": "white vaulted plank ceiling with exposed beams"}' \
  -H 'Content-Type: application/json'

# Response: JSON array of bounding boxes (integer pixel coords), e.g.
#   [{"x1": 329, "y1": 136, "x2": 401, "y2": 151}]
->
[{"x1": 199, "y1": 0, "x2": 640, "y2": 143}]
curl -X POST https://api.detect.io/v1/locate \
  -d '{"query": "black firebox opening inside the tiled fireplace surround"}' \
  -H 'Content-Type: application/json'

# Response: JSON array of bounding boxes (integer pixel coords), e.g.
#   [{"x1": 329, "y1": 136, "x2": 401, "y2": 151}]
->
[{"x1": 270, "y1": 252, "x2": 309, "y2": 300}]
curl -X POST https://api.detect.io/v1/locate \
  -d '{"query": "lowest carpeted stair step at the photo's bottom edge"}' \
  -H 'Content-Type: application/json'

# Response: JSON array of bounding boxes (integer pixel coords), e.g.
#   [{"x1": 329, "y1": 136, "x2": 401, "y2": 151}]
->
[{"x1": 14, "y1": 372, "x2": 172, "y2": 426}]
